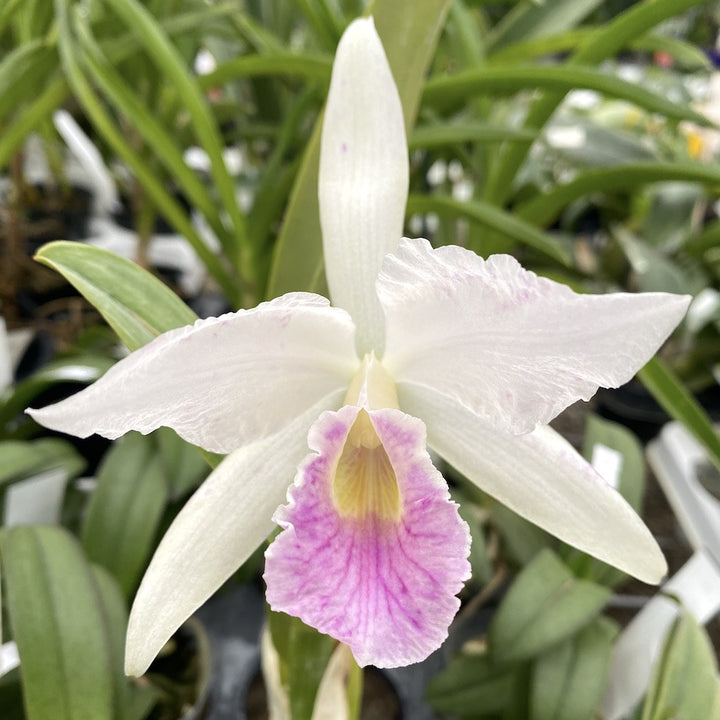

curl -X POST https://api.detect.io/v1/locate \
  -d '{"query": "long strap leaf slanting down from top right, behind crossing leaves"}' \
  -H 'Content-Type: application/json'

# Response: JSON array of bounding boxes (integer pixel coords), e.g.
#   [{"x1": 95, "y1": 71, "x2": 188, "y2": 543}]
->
[{"x1": 485, "y1": 0, "x2": 709, "y2": 204}]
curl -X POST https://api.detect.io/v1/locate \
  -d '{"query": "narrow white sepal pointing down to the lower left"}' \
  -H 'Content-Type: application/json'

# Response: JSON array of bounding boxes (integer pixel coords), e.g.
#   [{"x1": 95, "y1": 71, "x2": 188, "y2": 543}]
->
[{"x1": 125, "y1": 392, "x2": 342, "y2": 675}]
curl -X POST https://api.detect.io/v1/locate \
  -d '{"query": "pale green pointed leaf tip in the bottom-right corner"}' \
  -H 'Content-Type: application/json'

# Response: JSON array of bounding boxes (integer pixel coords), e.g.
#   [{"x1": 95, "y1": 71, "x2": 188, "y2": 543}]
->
[{"x1": 641, "y1": 611, "x2": 720, "y2": 720}]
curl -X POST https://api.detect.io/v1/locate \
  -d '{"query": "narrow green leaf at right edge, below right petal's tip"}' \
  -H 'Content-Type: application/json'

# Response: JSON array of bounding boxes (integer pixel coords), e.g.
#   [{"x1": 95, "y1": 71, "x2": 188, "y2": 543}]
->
[{"x1": 638, "y1": 357, "x2": 720, "y2": 470}]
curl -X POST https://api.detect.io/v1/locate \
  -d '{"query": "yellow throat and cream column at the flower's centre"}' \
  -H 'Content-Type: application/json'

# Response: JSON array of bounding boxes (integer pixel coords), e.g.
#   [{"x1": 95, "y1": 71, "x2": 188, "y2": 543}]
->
[{"x1": 332, "y1": 353, "x2": 402, "y2": 521}]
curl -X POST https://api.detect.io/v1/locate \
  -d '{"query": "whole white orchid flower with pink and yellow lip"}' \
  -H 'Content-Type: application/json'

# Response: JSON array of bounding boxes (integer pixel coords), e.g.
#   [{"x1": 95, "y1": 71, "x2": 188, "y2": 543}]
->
[{"x1": 29, "y1": 19, "x2": 689, "y2": 674}]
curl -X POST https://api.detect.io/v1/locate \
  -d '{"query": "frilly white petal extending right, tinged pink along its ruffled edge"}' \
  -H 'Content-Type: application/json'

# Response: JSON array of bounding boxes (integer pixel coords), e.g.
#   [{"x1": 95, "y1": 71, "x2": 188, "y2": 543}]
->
[{"x1": 378, "y1": 239, "x2": 690, "y2": 434}]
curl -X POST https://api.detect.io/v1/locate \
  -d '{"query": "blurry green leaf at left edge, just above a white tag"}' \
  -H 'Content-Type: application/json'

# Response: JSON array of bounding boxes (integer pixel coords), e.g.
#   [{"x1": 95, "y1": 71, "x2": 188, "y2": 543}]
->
[{"x1": 0, "y1": 438, "x2": 85, "y2": 488}]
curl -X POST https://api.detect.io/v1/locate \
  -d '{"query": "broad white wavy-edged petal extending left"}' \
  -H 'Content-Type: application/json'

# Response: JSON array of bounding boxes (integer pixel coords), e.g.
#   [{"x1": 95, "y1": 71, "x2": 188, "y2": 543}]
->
[{"x1": 28, "y1": 293, "x2": 358, "y2": 453}]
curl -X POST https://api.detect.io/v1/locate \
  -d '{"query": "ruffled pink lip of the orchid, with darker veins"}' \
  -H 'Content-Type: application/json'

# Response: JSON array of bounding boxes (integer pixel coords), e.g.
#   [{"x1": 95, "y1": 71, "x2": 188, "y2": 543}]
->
[{"x1": 265, "y1": 406, "x2": 470, "y2": 667}]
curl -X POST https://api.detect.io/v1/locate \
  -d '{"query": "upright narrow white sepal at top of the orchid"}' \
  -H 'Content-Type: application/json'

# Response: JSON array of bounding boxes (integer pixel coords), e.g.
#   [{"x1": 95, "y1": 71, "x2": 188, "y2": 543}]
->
[{"x1": 319, "y1": 18, "x2": 408, "y2": 355}]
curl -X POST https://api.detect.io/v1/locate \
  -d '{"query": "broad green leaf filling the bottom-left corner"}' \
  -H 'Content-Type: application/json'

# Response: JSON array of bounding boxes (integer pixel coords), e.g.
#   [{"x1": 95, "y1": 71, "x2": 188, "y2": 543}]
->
[{"x1": 0, "y1": 526, "x2": 113, "y2": 720}]
